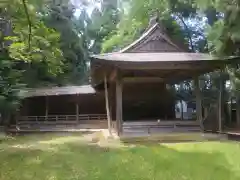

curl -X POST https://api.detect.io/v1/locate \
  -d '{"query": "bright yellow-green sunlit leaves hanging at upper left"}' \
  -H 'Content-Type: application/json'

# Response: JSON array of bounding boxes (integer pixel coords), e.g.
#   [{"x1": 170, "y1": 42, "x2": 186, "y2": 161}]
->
[{"x1": 3, "y1": 0, "x2": 63, "y2": 70}]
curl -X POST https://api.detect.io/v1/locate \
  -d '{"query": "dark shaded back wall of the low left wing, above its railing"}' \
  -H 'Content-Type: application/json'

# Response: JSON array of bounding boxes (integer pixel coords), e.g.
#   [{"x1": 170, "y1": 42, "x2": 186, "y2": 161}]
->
[{"x1": 21, "y1": 93, "x2": 106, "y2": 116}]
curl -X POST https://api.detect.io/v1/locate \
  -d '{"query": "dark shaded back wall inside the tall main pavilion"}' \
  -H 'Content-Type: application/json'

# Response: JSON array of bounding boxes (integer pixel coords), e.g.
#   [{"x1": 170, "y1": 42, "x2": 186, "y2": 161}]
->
[{"x1": 109, "y1": 83, "x2": 175, "y2": 121}]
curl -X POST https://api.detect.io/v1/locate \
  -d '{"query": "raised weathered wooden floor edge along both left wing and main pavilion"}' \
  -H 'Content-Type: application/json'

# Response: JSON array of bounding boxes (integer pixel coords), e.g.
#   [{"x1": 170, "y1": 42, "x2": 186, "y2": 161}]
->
[{"x1": 9, "y1": 120, "x2": 200, "y2": 136}]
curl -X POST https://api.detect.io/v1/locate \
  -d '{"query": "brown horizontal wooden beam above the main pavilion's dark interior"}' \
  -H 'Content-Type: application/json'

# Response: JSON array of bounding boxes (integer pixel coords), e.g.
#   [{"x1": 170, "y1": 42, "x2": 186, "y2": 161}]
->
[{"x1": 123, "y1": 77, "x2": 164, "y2": 83}]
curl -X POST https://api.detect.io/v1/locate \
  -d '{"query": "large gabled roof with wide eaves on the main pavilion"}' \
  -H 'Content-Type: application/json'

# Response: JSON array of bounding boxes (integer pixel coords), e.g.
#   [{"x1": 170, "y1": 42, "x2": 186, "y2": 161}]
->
[{"x1": 91, "y1": 15, "x2": 237, "y2": 84}]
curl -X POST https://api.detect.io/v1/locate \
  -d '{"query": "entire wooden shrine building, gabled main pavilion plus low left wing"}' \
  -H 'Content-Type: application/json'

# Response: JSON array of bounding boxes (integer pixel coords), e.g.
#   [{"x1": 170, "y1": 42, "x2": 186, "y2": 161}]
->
[{"x1": 17, "y1": 18, "x2": 239, "y2": 134}]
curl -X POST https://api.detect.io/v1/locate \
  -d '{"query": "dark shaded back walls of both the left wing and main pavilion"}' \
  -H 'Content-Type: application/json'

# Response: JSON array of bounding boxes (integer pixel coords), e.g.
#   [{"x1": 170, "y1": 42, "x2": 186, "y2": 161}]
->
[{"x1": 21, "y1": 83, "x2": 175, "y2": 121}]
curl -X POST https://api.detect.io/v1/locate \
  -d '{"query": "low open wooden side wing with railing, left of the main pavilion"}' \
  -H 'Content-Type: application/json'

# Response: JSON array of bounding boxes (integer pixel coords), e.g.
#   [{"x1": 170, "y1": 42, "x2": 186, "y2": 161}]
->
[{"x1": 13, "y1": 86, "x2": 107, "y2": 132}]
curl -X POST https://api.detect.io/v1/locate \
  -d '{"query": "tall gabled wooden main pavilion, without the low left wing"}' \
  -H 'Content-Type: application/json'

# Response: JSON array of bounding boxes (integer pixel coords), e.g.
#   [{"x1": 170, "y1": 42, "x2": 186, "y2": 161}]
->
[{"x1": 91, "y1": 18, "x2": 238, "y2": 134}]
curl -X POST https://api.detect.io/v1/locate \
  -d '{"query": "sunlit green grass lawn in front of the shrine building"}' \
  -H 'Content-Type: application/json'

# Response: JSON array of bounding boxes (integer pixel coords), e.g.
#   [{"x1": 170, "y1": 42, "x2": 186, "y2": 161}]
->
[{"x1": 0, "y1": 135, "x2": 240, "y2": 180}]
